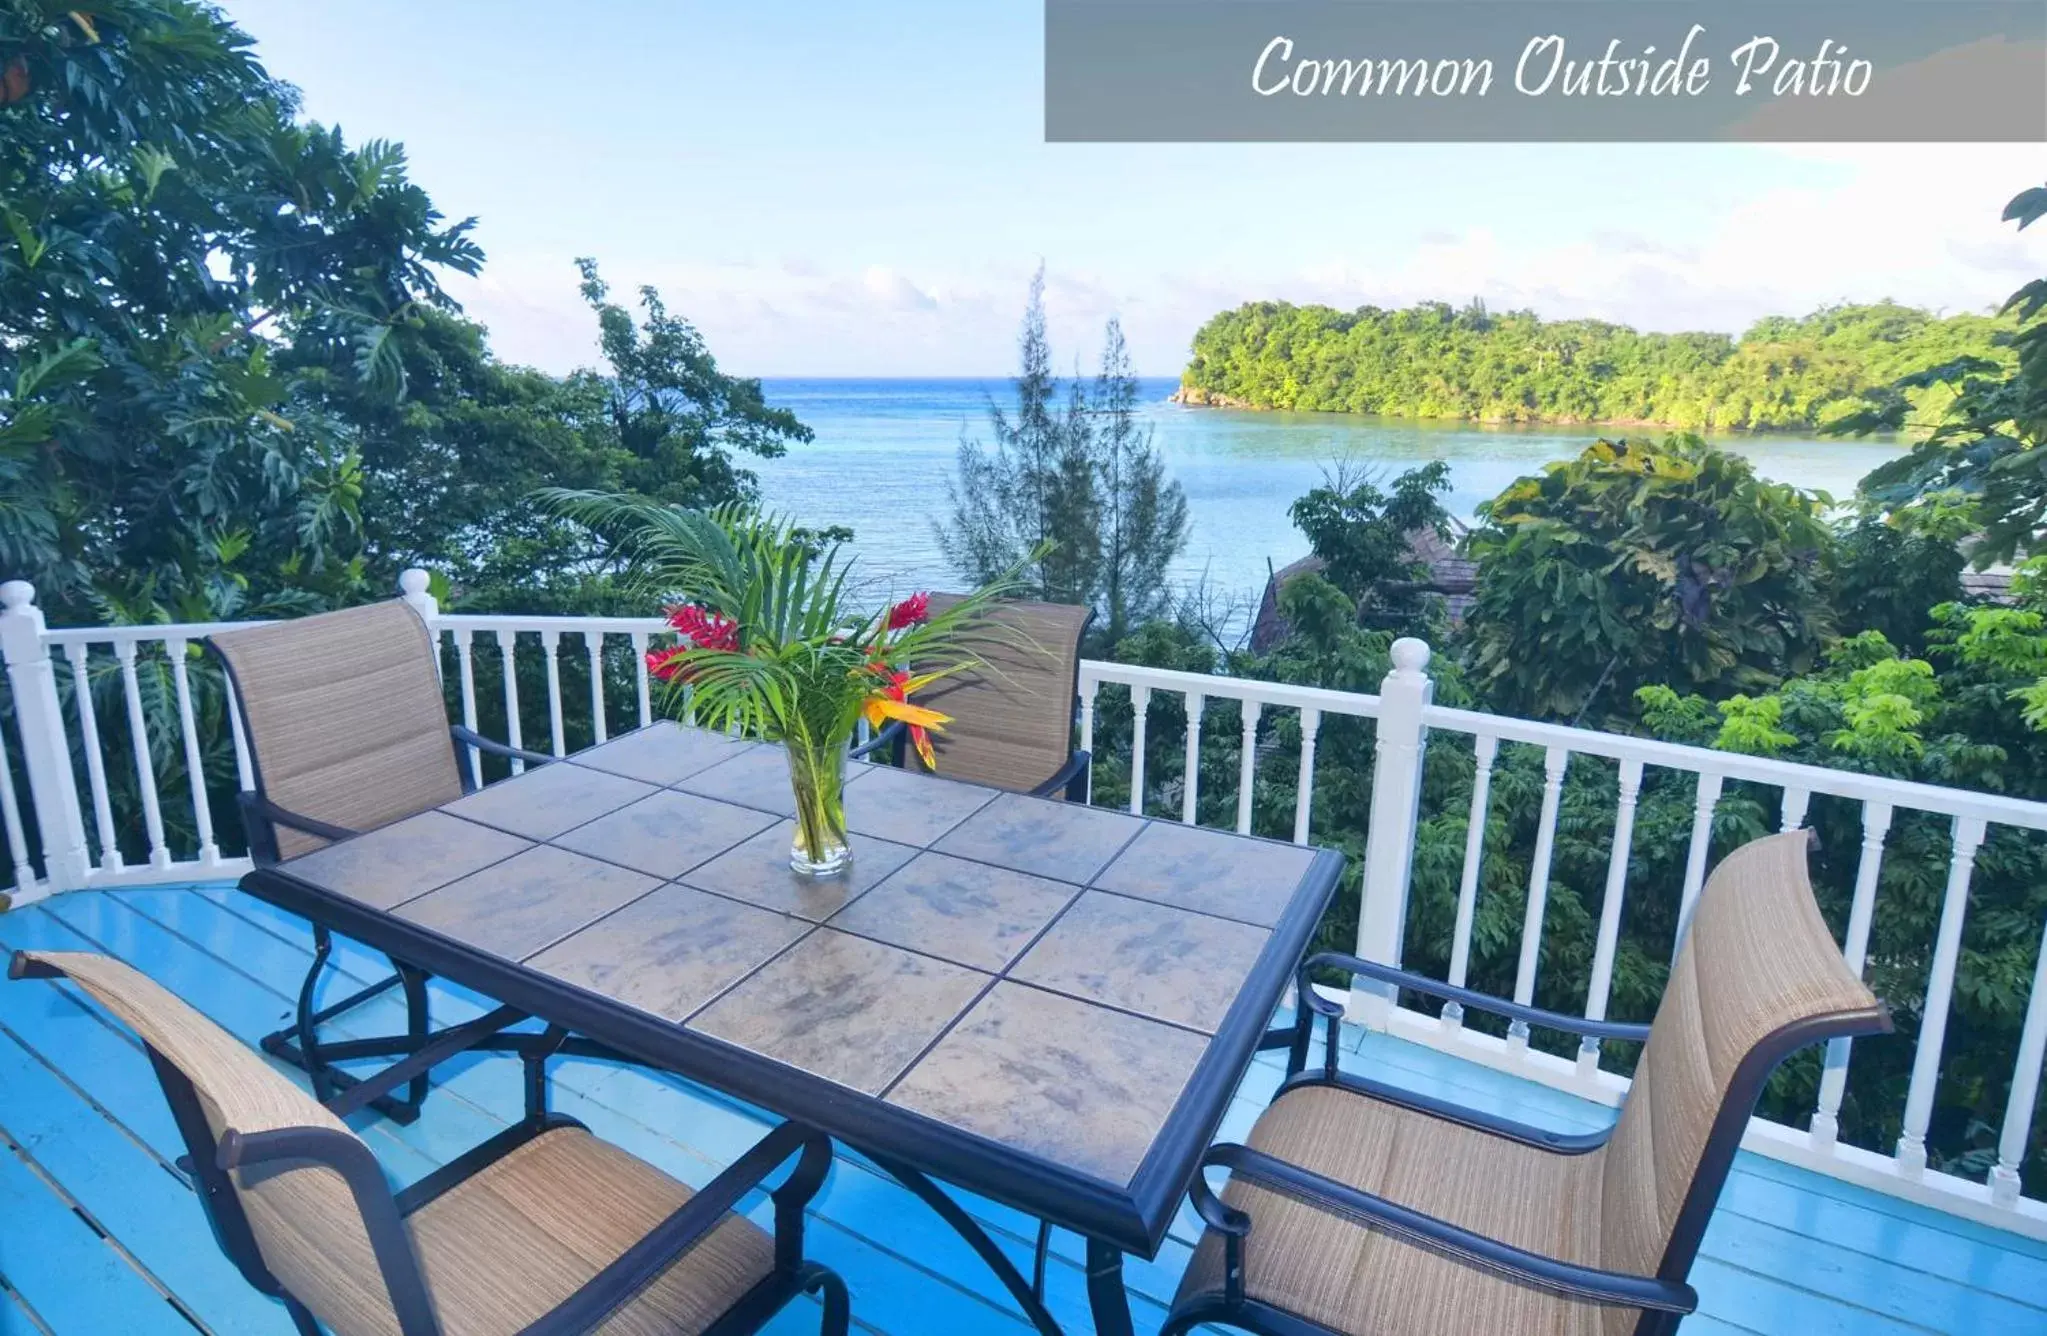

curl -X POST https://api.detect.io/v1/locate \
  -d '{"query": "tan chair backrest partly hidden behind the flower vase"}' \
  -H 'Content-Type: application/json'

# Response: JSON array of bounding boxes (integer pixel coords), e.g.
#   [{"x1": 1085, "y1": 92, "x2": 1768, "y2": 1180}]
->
[{"x1": 917, "y1": 593, "x2": 1095, "y2": 790}]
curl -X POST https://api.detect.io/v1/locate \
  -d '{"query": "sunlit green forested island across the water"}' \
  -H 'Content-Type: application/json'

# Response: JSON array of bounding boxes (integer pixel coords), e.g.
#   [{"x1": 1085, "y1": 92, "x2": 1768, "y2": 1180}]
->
[{"x1": 1175, "y1": 301, "x2": 2012, "y2": 432}]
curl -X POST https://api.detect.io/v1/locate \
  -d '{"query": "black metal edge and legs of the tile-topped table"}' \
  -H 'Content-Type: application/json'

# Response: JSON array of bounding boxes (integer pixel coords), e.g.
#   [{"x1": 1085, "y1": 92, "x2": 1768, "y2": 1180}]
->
[{"x1": 242, "y1": 849, "x2": 1343, "y2": 1336}]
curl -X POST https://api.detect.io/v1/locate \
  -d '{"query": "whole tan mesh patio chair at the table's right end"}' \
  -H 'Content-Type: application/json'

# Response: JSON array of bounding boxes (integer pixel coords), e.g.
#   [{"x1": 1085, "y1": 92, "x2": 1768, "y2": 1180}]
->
[{"x1": 1163, "y1": 831, "x2": 1889, "y2": 1336}]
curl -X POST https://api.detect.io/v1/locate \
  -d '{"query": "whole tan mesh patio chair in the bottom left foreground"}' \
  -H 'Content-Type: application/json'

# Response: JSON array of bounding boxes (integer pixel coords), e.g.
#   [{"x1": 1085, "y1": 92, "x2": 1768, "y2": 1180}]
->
[{"x1": 8, "y1": 951, "x2": 850, "y2": 1336}]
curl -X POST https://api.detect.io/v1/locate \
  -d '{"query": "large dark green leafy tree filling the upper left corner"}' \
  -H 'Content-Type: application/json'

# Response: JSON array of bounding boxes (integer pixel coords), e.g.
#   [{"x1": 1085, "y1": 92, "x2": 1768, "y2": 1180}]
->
[{"x1": 0, "y1": 0, "x2": 481, "y2": 620}]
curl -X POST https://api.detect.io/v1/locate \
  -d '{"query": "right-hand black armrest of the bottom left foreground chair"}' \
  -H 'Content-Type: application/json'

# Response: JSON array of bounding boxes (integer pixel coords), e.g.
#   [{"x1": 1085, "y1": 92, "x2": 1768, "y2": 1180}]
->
[{"x1": 520, "y1": 1123, "x2": 831, "y2": 1336}]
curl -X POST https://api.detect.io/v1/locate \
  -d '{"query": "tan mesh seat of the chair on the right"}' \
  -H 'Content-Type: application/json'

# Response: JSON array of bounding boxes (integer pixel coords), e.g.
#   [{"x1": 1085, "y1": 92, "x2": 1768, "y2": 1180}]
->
[{"x1": 1179, "y1": 1086, "x2": 1631, "y2": 1336}]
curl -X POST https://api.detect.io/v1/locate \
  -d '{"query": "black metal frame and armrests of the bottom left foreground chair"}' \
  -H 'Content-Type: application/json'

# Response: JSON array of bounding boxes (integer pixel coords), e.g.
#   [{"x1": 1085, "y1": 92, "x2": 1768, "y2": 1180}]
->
[{"x1": 8, "y1": 953, "x2": 852, "y2": 1336}]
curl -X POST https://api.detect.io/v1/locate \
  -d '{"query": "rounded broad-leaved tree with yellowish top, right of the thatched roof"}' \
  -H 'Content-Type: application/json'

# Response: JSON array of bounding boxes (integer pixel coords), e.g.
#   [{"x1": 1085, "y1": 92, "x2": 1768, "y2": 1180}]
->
[{"x1": 1466, "y1": 436, "x2": 1832, "y2": 718}]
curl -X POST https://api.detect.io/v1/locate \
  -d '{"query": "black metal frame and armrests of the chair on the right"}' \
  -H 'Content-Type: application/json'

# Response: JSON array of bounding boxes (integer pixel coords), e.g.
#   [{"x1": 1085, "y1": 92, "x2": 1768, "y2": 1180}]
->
[{"x1": 1161, "y1": 951, "x2": 1891, "y2": 1336}]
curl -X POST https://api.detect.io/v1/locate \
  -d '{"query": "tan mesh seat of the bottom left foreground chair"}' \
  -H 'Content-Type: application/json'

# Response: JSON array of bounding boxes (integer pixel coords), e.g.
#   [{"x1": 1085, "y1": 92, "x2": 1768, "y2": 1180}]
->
[{"x1": 405, "y1": 1127, "x2": 774, "y2": 1336}]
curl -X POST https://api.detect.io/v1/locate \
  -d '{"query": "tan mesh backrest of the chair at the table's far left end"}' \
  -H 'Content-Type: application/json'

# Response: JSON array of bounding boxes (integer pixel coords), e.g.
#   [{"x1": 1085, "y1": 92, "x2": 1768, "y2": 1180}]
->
[{"x1": 211, "y1": 599, "x2": 463, "y2": 857}]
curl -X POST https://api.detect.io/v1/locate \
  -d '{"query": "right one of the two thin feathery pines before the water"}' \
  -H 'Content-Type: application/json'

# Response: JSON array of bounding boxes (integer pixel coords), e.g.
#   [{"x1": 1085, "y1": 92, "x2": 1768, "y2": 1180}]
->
[{"x1": 1093, "y1": 317, "x2": 1187, "y2": 644}]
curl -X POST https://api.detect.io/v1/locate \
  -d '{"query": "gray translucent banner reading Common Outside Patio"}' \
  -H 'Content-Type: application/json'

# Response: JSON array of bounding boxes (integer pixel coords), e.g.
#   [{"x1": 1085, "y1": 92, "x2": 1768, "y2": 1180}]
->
[{"x1": 1044, "y1": 0, "x2": 2047, "y2": 143}]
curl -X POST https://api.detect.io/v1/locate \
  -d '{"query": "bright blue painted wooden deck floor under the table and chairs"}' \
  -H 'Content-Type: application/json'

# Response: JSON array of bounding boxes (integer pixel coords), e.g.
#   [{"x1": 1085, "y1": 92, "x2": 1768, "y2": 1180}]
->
[{"x1": 0, "y1": 884, "x2": 2047, "y2": 1336}]
